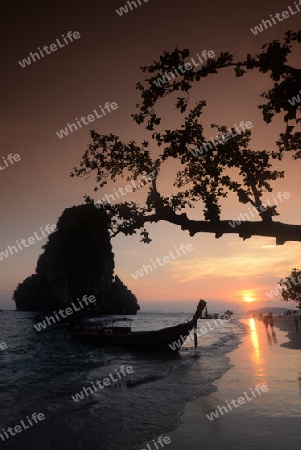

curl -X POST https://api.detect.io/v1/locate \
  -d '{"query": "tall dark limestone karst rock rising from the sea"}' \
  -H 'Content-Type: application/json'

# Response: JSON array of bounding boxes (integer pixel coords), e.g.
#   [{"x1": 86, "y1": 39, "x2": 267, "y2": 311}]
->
[{"x1": 13, "y1": 204, "x2": 140, "y2": 314}]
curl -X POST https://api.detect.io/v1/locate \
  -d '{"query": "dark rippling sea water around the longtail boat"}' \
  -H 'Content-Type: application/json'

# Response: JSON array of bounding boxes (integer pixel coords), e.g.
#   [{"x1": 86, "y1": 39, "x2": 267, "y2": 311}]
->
[{"x1": 0, "y1": 311, "x2": 246, "y2": 450}]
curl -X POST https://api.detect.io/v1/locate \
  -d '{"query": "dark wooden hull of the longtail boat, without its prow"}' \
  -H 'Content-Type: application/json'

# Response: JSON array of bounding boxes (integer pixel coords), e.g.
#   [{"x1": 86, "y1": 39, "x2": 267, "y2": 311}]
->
[{"x1": 72, "y1": 322, "x2": 193, "y2": 351}]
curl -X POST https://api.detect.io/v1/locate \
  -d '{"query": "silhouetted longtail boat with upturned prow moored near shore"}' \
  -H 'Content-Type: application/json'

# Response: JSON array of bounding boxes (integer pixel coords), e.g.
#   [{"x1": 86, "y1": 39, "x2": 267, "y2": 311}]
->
[{"x1": 71, "y1": 300, "x2": 207, "y2": 351}]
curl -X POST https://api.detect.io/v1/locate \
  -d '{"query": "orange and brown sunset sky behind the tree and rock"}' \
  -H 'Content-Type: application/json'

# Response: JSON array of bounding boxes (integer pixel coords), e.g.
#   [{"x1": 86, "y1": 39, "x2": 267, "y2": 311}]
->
[{"x1": 0, "y1": 0, "x2": 301, "y2": 310}]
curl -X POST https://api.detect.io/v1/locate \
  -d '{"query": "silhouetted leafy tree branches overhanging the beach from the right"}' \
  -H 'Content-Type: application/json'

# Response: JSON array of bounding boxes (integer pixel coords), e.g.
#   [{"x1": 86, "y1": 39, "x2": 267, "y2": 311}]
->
[{"x1": 71, "y1": 31, "x2": 301, "y2": 244}]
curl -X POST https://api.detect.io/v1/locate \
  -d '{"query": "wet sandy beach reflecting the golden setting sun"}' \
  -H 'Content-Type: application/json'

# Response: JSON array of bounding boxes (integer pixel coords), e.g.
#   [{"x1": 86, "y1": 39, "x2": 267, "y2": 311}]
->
[{"x1": 139, "y1": 316, "x2": 301, "y2": 450}]
